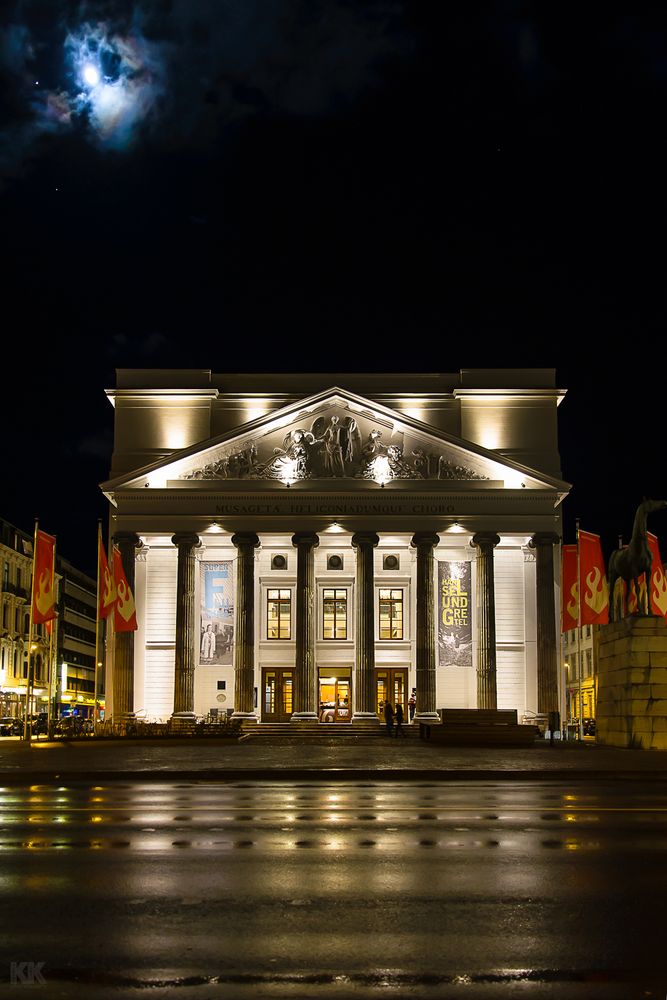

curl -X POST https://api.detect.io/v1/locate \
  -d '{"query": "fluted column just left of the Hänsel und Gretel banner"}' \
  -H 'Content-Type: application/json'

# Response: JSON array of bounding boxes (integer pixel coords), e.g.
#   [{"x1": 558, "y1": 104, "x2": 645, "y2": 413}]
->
[{"x1": 412, "y1": 531, "x2": 440, "y2": 725}]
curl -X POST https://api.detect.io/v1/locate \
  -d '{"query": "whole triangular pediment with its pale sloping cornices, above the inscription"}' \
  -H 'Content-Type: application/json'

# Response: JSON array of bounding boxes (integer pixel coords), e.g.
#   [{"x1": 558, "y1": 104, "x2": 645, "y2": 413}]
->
[{"x1": 102, "y1": 387, "x2": 568, "y2": 493}]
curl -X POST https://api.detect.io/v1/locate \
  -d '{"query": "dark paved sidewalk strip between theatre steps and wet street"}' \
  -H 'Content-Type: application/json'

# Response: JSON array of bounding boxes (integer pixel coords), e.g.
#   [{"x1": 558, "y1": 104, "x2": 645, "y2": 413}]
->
[{"x1": 0, "y1": 738, "x2": 667, "y2": 784}]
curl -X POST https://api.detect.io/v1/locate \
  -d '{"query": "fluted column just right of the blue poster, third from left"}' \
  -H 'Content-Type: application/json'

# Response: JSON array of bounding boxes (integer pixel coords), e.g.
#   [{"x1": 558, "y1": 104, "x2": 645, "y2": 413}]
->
[{"x1": 232, "y1": 531, "x2": 259, "y2": 719}]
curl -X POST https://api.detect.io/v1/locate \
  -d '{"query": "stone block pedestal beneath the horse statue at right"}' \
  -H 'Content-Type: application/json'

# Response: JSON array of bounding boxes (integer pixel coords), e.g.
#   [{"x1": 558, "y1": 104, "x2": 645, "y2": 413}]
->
[{"x1": 596, "y1": 616, "x2": 667, "y2": 750}]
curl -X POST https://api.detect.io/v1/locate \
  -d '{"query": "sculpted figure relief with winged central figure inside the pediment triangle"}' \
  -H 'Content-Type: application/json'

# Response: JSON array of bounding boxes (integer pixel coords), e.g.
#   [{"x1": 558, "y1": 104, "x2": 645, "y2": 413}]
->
[{"x1": 179, "y1": 401, "x2": 490, "y2": 483}]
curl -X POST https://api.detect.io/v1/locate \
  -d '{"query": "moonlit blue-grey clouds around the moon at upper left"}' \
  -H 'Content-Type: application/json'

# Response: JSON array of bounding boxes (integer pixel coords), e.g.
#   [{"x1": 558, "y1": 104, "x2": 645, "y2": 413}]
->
[{"x1": 0, "y1": 0, "x2": 409, "y2": 170}]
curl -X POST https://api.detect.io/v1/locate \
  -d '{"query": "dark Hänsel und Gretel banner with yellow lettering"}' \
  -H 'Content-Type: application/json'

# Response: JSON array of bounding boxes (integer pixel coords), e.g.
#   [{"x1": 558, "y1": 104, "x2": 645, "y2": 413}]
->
[{"x1": 438, "y1": 560, "x2": 472, "y2": 667}]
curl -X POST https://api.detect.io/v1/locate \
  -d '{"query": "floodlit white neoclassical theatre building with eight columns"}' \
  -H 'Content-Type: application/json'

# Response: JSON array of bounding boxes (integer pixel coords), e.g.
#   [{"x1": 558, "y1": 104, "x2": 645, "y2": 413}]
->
[{"x1": 102, "y1": 369, "x2": 570, "y2": 731}]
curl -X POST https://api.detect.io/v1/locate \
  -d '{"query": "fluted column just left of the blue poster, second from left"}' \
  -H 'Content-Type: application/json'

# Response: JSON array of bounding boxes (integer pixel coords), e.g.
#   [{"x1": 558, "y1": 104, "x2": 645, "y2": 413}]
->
[{"x1": 171, "y1": 533, "x2": 201, "y2": 719}]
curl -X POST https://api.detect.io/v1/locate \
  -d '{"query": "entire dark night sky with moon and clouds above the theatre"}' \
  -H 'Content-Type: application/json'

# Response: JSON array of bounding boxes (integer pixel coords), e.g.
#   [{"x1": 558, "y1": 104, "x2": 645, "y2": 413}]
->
[{"x1": 0, "y1": 0, "x2": 667, "y2": 574}]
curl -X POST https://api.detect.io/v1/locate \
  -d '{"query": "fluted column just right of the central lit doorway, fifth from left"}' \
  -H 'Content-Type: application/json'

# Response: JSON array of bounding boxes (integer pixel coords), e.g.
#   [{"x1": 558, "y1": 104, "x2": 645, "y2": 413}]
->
[{"x1": 352, "y1": 531, "x2": 380, "y2": 722}]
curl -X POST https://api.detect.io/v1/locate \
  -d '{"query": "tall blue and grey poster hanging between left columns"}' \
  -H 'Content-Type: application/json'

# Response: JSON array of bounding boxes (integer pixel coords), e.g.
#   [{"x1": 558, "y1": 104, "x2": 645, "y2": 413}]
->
[{"x1": 199, "y1": 561, "x2": 234, "y2": 663}]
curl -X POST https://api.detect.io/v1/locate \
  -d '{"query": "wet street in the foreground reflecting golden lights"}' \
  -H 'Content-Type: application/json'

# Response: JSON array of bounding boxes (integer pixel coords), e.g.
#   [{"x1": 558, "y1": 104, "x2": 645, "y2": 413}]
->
[{"x1": 0, "y1": 777, "x2": 667, "y2": 1000}]
